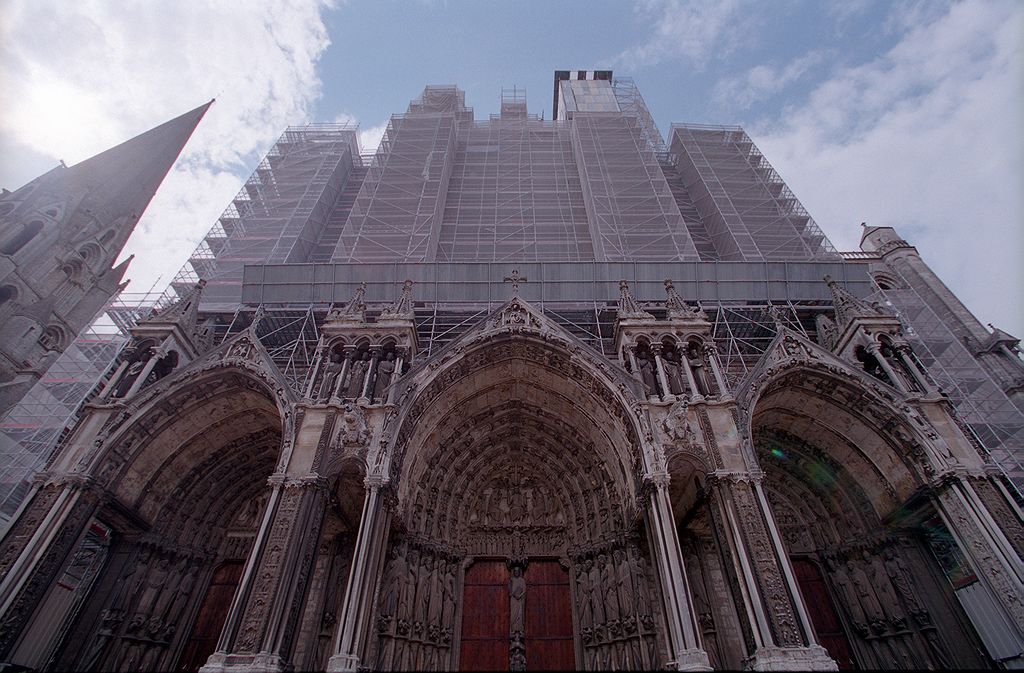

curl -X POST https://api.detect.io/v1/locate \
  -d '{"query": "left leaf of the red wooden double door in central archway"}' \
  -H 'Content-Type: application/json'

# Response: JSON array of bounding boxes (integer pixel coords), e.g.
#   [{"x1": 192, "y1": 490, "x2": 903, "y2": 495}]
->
[{"x1": 459, "y1": 560, "x2": 509, "y2": 671}]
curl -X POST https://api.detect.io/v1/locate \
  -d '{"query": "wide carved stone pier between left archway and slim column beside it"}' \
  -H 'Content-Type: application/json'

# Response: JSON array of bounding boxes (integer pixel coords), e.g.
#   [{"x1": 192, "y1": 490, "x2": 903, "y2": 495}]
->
[{"x1": 201, "y1": 474, "x2": 328, "y2": 673}]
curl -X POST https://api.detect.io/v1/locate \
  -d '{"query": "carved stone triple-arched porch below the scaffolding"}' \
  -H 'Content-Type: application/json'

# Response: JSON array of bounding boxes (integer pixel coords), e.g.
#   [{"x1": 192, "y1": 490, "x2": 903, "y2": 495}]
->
[{"x1": 0, "y1": 272, "x2": 1024, "y2": 673}]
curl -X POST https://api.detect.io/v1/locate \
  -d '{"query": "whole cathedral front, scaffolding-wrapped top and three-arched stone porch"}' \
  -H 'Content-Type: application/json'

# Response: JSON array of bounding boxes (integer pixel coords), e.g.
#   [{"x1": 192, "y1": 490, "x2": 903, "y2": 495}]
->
[{"x1": 0, "y1": 71, "x2": 1024, "y2": 673}]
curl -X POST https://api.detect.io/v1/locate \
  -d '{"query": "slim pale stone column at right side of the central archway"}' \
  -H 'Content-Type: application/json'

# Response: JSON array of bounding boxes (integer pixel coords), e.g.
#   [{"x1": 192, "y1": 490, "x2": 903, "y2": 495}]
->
[{"x1": 646, "y1": 474, "x2": 712, "y2": 671}]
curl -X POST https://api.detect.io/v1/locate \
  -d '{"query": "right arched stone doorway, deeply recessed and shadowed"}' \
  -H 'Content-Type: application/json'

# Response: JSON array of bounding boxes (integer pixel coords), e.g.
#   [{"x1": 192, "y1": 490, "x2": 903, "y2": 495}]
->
[{"x1": 751, "y1": 368, "x2": 985, "y2": 669}]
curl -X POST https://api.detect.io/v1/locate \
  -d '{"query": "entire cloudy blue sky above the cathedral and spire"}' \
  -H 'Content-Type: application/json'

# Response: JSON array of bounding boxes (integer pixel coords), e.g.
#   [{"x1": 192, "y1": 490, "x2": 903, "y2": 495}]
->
[{"x1": 0, "y1": 0, "x2": 1024, "y2": 336}]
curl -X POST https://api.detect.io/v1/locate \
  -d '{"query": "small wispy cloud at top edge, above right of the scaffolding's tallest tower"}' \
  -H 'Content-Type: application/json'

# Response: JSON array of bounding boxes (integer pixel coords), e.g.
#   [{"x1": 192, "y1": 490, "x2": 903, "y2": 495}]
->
[{"x1": 613, "y1": 0, "x2": 745, "y2": 71}]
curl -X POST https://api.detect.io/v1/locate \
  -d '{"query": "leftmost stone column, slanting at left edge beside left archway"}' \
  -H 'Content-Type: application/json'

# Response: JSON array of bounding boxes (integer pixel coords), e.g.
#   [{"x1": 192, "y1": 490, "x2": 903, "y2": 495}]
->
[{"x1": 0, "y1": 481, "x2": 99, "y2": 660}]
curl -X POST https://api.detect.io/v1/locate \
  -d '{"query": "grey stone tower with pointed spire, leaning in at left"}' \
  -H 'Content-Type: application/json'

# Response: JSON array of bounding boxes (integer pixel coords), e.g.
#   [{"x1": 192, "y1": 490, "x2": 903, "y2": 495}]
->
[{"x1": 0, "y1": 101, "x2": 212, "y2": 414}]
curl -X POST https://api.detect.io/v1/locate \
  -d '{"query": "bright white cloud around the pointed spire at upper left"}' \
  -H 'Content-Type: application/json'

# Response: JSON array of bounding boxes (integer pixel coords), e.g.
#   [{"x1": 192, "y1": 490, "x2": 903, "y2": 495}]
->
[{"x1": 0, "y1": 0, "x2": 330, "y2": 291}]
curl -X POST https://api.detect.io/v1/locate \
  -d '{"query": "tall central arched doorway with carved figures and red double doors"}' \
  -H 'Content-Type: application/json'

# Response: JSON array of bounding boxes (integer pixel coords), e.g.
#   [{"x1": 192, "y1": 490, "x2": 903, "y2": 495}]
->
[{"x1": 369, "y1": 333, "x2": 660, "y2": 670}]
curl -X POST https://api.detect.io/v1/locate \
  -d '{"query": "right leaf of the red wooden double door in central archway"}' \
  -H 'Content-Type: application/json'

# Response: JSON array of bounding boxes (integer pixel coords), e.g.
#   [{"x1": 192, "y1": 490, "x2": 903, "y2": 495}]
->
[{"x1": 524, "y1": 560, "x2": 575, "y2": 671}]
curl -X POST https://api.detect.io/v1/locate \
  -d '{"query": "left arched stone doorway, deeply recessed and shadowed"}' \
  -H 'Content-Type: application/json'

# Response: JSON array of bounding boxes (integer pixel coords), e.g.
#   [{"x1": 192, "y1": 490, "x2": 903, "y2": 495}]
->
[{"x1": 37, "y1": 368, "x2": 283, "y2": 671}]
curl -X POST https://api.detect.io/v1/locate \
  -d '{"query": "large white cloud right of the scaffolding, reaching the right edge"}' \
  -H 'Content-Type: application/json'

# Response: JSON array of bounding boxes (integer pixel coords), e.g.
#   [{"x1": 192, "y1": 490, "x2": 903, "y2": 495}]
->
[{"x1": 751, "y1": 1, "x2": 1024, "y2": 335}]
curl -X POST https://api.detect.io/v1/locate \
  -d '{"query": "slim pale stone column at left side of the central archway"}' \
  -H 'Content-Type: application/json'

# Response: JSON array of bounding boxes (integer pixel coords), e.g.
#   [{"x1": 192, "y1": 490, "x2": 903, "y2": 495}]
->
[{"x1": 327, "y1": 476, "x2": 388, "y2": 672}]
